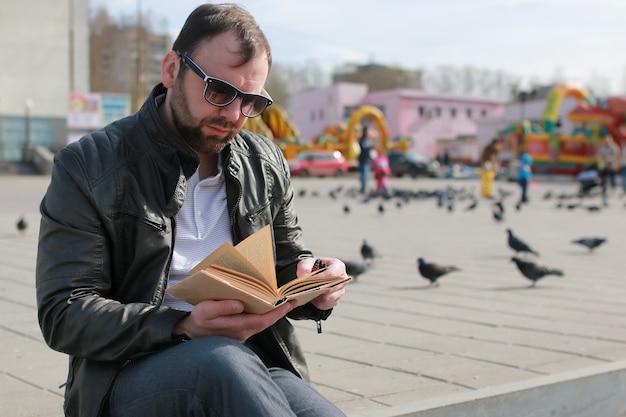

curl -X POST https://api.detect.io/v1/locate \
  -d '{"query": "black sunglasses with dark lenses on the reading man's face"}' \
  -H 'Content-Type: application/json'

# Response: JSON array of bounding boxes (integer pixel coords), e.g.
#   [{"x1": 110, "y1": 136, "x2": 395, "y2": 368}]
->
[{"x1": 176, "y1": 51, "x2": 272, "y2": 117}]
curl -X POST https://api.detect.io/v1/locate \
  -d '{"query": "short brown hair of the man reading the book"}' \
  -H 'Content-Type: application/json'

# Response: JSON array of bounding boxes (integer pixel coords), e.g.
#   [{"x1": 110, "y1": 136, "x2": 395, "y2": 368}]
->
[{"x1": 172, "y1": 3, "x2": 272, "y2": 68}]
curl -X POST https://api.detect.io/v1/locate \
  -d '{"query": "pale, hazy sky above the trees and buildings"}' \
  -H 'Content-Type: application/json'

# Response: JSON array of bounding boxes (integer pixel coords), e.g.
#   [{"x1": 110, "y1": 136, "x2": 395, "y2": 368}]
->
[{"x1": 89, "y1": 0, "x2": 626, "y2": 95}]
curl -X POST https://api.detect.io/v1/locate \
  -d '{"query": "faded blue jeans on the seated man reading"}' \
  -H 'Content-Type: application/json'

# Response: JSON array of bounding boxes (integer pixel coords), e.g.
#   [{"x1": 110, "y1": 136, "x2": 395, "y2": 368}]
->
[{"x1": 109, "y1": 336, "x2": 345, "y2": 417}]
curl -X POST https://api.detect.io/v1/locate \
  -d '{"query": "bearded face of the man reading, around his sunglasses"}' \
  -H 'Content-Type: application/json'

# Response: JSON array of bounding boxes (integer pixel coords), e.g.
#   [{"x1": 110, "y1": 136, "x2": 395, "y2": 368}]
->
[{"x1": 167, "y1": 33, "x2": 269, "y2": 154}]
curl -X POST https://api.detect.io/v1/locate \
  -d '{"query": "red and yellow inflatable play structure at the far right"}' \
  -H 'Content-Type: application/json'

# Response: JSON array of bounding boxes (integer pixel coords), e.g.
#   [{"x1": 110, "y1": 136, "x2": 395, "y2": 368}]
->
[{"x1": 501, "y1": 83, "x2": 626, "y2": 174}]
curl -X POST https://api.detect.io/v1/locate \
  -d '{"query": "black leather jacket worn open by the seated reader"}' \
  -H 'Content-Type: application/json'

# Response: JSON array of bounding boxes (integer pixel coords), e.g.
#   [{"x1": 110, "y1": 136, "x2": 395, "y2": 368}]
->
[{"x1": 37, "y1": 85, "x2": 330, "y2": 417}]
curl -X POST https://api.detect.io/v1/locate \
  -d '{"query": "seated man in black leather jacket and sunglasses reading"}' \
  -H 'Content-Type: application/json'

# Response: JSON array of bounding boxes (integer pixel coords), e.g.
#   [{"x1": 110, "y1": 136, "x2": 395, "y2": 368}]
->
[{"x1": 37, "y1": 4, "x2": 346, "y2": 417}]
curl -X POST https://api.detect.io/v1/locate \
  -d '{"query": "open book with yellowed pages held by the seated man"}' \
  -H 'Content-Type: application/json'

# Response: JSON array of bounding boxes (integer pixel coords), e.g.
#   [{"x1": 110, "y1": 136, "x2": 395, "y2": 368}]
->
[{"x1": 167, "y1": 225, "x2": 350, "y2": 314}]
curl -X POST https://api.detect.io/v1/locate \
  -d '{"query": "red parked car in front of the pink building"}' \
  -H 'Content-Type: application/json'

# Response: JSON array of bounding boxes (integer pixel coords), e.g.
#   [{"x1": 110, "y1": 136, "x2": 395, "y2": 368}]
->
[{"x1": 288, "y1": 150, "x2": 352, "y2": 177}]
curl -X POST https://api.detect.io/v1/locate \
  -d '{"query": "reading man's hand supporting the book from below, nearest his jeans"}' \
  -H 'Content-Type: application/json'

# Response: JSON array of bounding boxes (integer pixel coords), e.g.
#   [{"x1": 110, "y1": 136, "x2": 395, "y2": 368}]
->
[{"x1": 173, "y1": 300, "x2": 297, "y2": 342}]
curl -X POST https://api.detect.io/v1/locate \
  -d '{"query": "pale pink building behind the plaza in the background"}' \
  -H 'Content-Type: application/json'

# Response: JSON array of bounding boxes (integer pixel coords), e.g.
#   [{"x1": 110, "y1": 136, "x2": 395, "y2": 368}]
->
[{"x1": 289, "y1": 83, "x2": 504, "y2": 158}]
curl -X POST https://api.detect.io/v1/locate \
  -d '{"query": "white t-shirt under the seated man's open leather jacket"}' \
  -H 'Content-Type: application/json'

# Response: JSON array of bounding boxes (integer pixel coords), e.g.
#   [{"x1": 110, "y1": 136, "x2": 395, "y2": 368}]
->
[{"x1": 163, "y1": 161, "x2": 233, "y2": 311}]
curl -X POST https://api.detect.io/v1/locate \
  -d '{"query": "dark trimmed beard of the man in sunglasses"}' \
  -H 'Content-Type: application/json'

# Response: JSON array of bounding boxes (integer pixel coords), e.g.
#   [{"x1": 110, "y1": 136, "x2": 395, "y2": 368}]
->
[{"x1": 171, "y1": 80, "x2": 239, "y2": 154}]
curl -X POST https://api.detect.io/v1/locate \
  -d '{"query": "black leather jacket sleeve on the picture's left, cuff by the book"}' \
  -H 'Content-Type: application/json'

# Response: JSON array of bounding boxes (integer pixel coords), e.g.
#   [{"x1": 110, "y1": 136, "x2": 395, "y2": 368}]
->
[{"x1": 36, "y1": 150, "x2": 186, "y2": 361}]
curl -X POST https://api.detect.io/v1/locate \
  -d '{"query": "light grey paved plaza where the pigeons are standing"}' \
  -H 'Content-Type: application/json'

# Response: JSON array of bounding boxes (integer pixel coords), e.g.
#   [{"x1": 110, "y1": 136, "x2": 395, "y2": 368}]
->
[{"x1": 0, "y1": 171, "x2": 626, "y2": 417}]
